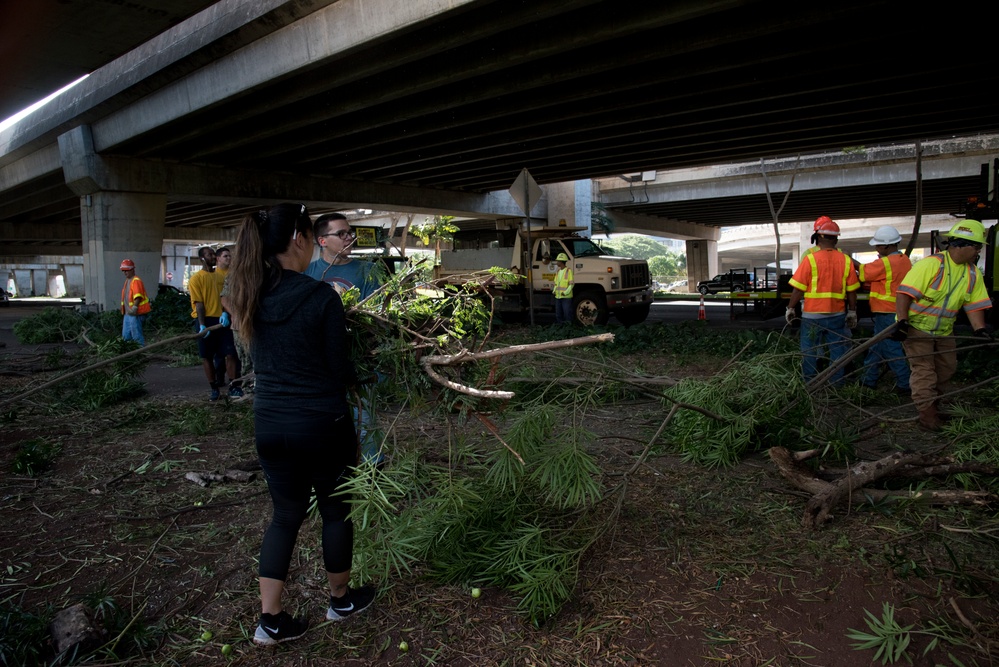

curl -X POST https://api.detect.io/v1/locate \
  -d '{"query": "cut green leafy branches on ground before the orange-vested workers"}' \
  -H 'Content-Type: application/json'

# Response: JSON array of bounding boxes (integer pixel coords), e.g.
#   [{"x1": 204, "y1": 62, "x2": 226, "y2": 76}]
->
[{"x1": 666, "y1": 354, "x2": 811, "y2": 468}]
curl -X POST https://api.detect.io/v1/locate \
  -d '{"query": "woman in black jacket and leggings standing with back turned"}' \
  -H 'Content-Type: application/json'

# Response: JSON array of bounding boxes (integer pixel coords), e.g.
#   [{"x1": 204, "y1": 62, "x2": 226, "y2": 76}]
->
[{"x1": 229, "y1": 204, "x2": 375, "y2": 645}]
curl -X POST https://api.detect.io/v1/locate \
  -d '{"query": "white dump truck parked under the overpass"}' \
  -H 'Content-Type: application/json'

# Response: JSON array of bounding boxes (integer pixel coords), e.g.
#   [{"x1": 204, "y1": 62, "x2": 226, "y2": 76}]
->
[{"x1": 437, "y1": 224, "x2": 652, "y2": 325}]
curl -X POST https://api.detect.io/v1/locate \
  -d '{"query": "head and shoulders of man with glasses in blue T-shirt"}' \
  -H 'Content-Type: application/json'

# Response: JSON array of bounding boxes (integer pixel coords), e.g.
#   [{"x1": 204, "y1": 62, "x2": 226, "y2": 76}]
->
[{"x1": 305, "y1": 213, "x2": 380, "y2": 300}]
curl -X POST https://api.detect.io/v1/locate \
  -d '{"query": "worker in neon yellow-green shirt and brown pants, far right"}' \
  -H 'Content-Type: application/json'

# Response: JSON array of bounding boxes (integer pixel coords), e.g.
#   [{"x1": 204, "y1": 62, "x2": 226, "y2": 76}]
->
[{"x1": 892, "y1": 220, "x2": 992, "y2": 431}]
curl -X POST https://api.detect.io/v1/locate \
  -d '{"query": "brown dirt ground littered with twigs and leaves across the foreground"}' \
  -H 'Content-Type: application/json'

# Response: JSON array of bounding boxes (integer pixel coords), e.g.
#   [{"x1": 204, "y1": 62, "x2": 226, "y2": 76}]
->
[{"x1": 0, "y1": 306, "x2": 999, "y2": 667}]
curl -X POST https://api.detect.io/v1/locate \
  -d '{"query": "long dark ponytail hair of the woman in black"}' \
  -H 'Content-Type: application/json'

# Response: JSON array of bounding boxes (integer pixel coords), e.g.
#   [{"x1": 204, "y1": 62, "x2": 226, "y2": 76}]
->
[{"x1": 227, "y1": 204, "x2": 312, "y2": 343}]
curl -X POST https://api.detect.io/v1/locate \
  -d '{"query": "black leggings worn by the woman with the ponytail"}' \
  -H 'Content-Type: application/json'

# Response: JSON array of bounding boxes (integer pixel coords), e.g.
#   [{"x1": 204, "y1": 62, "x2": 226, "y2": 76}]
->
[{"x1": 254, "y1": 410, "x2": 357, "y2": 581}]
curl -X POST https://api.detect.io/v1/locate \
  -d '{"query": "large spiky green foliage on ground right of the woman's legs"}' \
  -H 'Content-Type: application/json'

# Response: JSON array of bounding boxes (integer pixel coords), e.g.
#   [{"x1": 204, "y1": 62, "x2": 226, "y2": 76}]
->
[{"x1": 350, "y1": 404, "x2": 602, "y2": 624}]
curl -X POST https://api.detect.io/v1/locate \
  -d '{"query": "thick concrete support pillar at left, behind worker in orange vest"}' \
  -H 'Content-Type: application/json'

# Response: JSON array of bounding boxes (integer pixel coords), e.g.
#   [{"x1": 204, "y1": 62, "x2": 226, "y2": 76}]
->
[{"x1": 80, "y1": 192, "x2": 166, "y2": 310}]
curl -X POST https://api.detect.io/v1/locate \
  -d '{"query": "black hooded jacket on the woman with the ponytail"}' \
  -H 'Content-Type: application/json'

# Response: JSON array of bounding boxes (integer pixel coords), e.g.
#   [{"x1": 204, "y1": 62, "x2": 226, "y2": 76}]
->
[{"x1": 250, "y1": 271, "x2": 357, "y2": 415}]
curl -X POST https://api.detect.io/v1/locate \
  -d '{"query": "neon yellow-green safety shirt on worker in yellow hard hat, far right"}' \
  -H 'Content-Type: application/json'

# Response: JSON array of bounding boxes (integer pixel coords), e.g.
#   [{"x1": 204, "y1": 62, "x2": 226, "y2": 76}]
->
[{"x1": 898, "y1": 252, "x2": 992, "y2": 336}]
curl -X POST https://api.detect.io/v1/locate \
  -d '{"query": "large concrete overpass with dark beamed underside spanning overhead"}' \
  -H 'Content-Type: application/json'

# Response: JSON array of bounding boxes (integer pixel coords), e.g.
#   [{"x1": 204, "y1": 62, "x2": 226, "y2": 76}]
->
[{"x1": 0, "y1": 0, "x2": 999, "y2": 301}]
